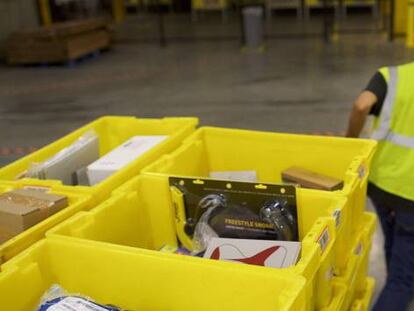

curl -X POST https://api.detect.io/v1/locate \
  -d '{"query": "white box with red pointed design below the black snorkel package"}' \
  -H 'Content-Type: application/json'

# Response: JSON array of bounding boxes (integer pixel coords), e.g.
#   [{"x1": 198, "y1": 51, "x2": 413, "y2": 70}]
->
[{"x1": 204, "y1": 238, "x2": 301, "y2": 268}]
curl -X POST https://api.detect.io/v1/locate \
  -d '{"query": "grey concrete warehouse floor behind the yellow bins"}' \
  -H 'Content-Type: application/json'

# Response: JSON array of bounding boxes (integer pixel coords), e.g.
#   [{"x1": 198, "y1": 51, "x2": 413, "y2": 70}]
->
[{"x1": 0, "y1": 11, "x2": 414, "y2": 310}]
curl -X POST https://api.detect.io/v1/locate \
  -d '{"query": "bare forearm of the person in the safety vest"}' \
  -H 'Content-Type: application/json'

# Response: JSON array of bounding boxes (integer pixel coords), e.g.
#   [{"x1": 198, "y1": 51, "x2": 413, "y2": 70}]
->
[{"x1": 346, "y1": 91, "x2": 378, "y2": 137}]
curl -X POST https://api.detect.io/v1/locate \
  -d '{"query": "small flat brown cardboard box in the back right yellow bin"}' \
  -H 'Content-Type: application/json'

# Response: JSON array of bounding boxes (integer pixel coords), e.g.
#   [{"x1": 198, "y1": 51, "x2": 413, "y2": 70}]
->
[{"x1": 282, "y1": 167, "x2": 344, "y2": 191}]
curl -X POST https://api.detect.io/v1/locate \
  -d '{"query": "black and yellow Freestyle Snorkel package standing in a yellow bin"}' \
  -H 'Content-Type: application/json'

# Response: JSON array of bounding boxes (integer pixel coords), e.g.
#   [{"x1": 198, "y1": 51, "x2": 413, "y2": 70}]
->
[{"x1": 170, "y1": 177, "x2": 298, "y2": 252}]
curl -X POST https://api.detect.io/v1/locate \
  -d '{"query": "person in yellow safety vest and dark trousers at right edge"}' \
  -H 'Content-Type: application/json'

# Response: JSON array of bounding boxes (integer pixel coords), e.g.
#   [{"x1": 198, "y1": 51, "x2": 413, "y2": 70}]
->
[{"x1": 347, "y1": 63, "x2": 414, "y2": 311}]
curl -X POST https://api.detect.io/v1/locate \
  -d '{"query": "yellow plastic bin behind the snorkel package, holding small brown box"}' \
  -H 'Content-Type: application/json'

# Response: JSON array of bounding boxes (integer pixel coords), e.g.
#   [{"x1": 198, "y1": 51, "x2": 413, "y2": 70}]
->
[{"x1": 143, "y1": 127, "x2": 376, "y2": 271}]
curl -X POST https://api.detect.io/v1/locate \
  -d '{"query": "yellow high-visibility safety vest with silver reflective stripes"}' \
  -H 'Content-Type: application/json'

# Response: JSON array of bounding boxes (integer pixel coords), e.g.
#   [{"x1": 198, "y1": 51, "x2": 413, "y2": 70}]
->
[{"x1": 369, "y1": 63, "x2": 414, "y2": 201}]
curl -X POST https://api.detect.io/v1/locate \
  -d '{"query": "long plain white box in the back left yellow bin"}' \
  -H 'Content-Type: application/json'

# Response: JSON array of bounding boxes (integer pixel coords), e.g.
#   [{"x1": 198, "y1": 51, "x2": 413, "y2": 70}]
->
[{"x1": 87, "y1": 136, "x2": 167, "y2": 186}]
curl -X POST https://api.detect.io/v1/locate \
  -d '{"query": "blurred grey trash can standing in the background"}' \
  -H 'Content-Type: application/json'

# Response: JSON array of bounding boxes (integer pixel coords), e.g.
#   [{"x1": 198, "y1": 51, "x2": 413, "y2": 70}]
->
[{"x1": 242, "y1": 5, "x2": 264, "y2": 49}]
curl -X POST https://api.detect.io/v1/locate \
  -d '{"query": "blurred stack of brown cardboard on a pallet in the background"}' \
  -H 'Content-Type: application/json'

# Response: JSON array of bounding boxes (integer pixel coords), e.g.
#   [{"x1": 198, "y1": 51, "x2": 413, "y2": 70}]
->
[{"x1": 7, "y1": 18, "x2": 111, "y2": 65}]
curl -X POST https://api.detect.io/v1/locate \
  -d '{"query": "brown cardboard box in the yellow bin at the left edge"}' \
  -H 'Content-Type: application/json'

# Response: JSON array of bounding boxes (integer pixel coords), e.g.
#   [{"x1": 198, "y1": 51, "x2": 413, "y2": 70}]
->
[{"x1": 0, "y1": 189, "x2": 68, "y2": 243}]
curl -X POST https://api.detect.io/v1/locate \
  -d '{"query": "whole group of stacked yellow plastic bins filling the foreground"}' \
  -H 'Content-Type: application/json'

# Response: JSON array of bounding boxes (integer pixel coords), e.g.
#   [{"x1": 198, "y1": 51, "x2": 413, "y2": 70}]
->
[{"x1": 0, "y1": 117, "x2": 376, "y2": 311}]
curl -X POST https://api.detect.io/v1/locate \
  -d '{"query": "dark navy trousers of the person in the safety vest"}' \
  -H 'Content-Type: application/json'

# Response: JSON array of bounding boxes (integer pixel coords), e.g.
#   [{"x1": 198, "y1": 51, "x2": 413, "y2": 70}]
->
[{"x1": 368, "y1": 184, "x2": 414, "y2": 311}]
